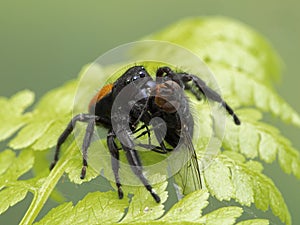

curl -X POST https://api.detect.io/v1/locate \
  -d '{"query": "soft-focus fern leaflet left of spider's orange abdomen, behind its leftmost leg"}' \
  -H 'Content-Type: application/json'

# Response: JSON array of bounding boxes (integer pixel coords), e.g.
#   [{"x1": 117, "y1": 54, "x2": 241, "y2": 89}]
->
[{"x1": 9, "y1": 81, "x2": 77, "y2": 150}]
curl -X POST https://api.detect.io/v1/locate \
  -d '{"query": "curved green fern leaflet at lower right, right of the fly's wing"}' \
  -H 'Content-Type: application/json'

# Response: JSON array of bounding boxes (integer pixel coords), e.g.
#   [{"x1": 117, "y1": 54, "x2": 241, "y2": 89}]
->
[{"x1": 204, "y1": 152, "x2": 291, "y2": 224}]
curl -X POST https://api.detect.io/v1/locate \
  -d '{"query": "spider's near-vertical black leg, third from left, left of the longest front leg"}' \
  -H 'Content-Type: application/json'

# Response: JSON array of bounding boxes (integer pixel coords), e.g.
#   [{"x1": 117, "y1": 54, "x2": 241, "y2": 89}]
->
[{"x1": 107, "y1": 130, "x2": 124, "y2": 199}]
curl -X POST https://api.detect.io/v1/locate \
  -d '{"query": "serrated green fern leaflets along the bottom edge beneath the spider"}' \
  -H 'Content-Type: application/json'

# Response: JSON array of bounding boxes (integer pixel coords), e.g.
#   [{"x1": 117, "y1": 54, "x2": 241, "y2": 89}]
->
[{"x1": 35, "y1": 189, "x2": 246, "y2": 225}]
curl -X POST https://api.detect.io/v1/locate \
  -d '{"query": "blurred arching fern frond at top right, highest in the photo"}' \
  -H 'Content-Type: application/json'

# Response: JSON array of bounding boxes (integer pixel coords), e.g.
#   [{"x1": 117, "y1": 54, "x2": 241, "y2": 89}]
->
[{"x1": 147, "y1": 17, "x2": 282, "y2": 86}]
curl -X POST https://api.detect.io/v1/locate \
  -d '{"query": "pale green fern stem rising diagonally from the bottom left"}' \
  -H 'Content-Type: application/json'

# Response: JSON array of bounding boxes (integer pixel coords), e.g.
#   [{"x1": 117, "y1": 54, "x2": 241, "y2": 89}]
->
[{"x1": 19, "y1": 142, "x2": 77, "y2": 225}]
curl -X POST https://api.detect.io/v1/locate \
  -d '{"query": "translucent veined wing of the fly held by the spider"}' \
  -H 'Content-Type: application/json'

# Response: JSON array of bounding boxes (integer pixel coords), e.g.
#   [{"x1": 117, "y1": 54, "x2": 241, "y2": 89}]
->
[{"x1": 174, "y1": 132, "x2": 202, "y2": 195}]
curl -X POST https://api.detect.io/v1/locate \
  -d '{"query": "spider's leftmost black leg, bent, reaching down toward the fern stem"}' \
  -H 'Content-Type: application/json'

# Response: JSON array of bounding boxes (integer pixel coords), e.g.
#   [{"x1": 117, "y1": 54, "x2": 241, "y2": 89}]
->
[{"x1": 50, "y1": 114, "x2": 98, "y2": 170}]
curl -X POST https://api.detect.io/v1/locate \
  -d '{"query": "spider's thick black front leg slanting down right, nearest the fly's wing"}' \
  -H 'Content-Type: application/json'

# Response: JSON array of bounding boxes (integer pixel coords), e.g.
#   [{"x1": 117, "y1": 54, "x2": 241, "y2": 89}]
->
[{"x1": 118, "y1": 129, "x2": 160, "y2": 203}]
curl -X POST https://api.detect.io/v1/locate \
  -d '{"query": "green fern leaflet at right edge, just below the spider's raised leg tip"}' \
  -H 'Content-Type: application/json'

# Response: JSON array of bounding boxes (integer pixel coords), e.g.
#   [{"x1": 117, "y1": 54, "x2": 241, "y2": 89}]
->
[{"x1": 223, "y1": 109, "x2": 300, "y2": 178}]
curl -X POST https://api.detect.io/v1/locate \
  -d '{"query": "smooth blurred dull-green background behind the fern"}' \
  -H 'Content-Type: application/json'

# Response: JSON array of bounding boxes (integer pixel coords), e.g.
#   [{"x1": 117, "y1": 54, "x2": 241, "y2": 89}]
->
[{"x1": 0, "y1": 0, "x2": 300, "y2": 224}]
